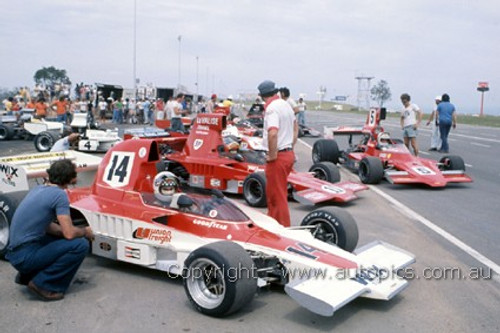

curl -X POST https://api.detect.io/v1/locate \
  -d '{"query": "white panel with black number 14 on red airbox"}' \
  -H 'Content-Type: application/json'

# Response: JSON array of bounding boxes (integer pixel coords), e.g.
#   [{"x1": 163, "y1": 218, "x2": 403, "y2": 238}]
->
[{"x1": 102, "y1": 152, "x2": 134, "y2": 187}]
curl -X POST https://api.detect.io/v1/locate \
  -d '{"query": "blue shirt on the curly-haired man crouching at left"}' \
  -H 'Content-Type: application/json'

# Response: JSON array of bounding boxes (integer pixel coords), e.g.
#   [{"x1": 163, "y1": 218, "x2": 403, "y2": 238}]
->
[{"x1": 9, "y1": 185, "x2": 70, "y2": 249}]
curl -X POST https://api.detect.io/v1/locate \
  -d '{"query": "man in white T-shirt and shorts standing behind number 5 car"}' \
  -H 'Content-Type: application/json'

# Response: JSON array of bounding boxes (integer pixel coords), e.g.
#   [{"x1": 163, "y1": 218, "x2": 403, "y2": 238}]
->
[{"x1": 400, "y1": 94, "x2": 422, "y2": 156}]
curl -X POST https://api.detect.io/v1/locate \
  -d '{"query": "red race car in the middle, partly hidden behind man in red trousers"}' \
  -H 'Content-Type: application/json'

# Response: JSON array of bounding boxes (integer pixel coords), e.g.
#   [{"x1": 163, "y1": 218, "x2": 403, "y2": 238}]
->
[{"x1": 154, "y1": 113, "x2": 367, "y2": 207}]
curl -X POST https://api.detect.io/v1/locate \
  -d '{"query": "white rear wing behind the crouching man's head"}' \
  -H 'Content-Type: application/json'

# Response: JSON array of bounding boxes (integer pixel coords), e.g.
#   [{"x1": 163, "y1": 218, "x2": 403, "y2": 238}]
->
[{"x1": 0, "y1": 150, "x2": 102, "y2": 193}]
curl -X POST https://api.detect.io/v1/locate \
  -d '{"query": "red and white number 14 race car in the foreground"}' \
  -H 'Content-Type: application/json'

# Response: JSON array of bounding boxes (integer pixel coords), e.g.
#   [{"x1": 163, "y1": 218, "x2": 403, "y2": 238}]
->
[{"x1": 0, "y1": 140, "x2": 415, "y2": 316}]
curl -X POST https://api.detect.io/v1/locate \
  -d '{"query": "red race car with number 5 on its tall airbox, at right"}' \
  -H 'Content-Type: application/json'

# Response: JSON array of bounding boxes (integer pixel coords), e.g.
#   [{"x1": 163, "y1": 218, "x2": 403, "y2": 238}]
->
[{"x1": 312, "y1": 108, "x2": 472, "y2": 187}]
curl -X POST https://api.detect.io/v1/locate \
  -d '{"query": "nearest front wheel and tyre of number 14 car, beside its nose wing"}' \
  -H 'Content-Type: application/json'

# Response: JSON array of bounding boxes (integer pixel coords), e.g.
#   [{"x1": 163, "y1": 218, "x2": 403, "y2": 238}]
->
[{"x1": 183, "y1": 241, "x2": 257, "y2": 317}]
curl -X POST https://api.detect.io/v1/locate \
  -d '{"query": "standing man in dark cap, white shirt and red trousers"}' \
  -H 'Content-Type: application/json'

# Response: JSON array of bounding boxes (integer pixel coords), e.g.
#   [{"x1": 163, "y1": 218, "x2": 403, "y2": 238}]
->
[{"x1": 258, "y1": 80, "x2": 298, "y2": 227}]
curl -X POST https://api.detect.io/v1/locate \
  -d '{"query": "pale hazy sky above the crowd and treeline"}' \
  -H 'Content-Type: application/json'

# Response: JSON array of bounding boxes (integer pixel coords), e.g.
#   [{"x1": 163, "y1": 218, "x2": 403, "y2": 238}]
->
[{"x1": 0, "y1": 0, "x2": 500, "y2": 115}]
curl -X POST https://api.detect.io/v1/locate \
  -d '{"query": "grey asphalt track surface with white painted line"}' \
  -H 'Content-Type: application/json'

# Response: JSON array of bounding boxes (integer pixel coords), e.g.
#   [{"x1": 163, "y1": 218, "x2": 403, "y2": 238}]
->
[{"x1": 0, "y1": 111, "x2": 500, "y2": 332}]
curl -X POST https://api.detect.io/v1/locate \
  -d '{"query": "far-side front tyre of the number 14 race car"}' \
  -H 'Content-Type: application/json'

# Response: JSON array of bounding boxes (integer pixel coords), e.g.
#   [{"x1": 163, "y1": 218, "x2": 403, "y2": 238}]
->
[{"x1": 300, "y1": 207, "x2": 359, "y2": 252}]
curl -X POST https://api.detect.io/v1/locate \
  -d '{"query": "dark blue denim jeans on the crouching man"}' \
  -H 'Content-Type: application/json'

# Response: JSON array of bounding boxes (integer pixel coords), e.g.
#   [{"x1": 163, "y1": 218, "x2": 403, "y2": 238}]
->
[{"x1": 6, "y1": 235, "x2": 89, "y2": 293}]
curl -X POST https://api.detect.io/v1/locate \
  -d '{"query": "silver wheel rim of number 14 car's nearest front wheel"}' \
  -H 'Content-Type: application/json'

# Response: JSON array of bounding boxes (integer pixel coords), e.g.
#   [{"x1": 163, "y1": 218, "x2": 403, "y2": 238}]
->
[{"x1": 186, "y1": 258, "x2": 226, "y2": 309}]
